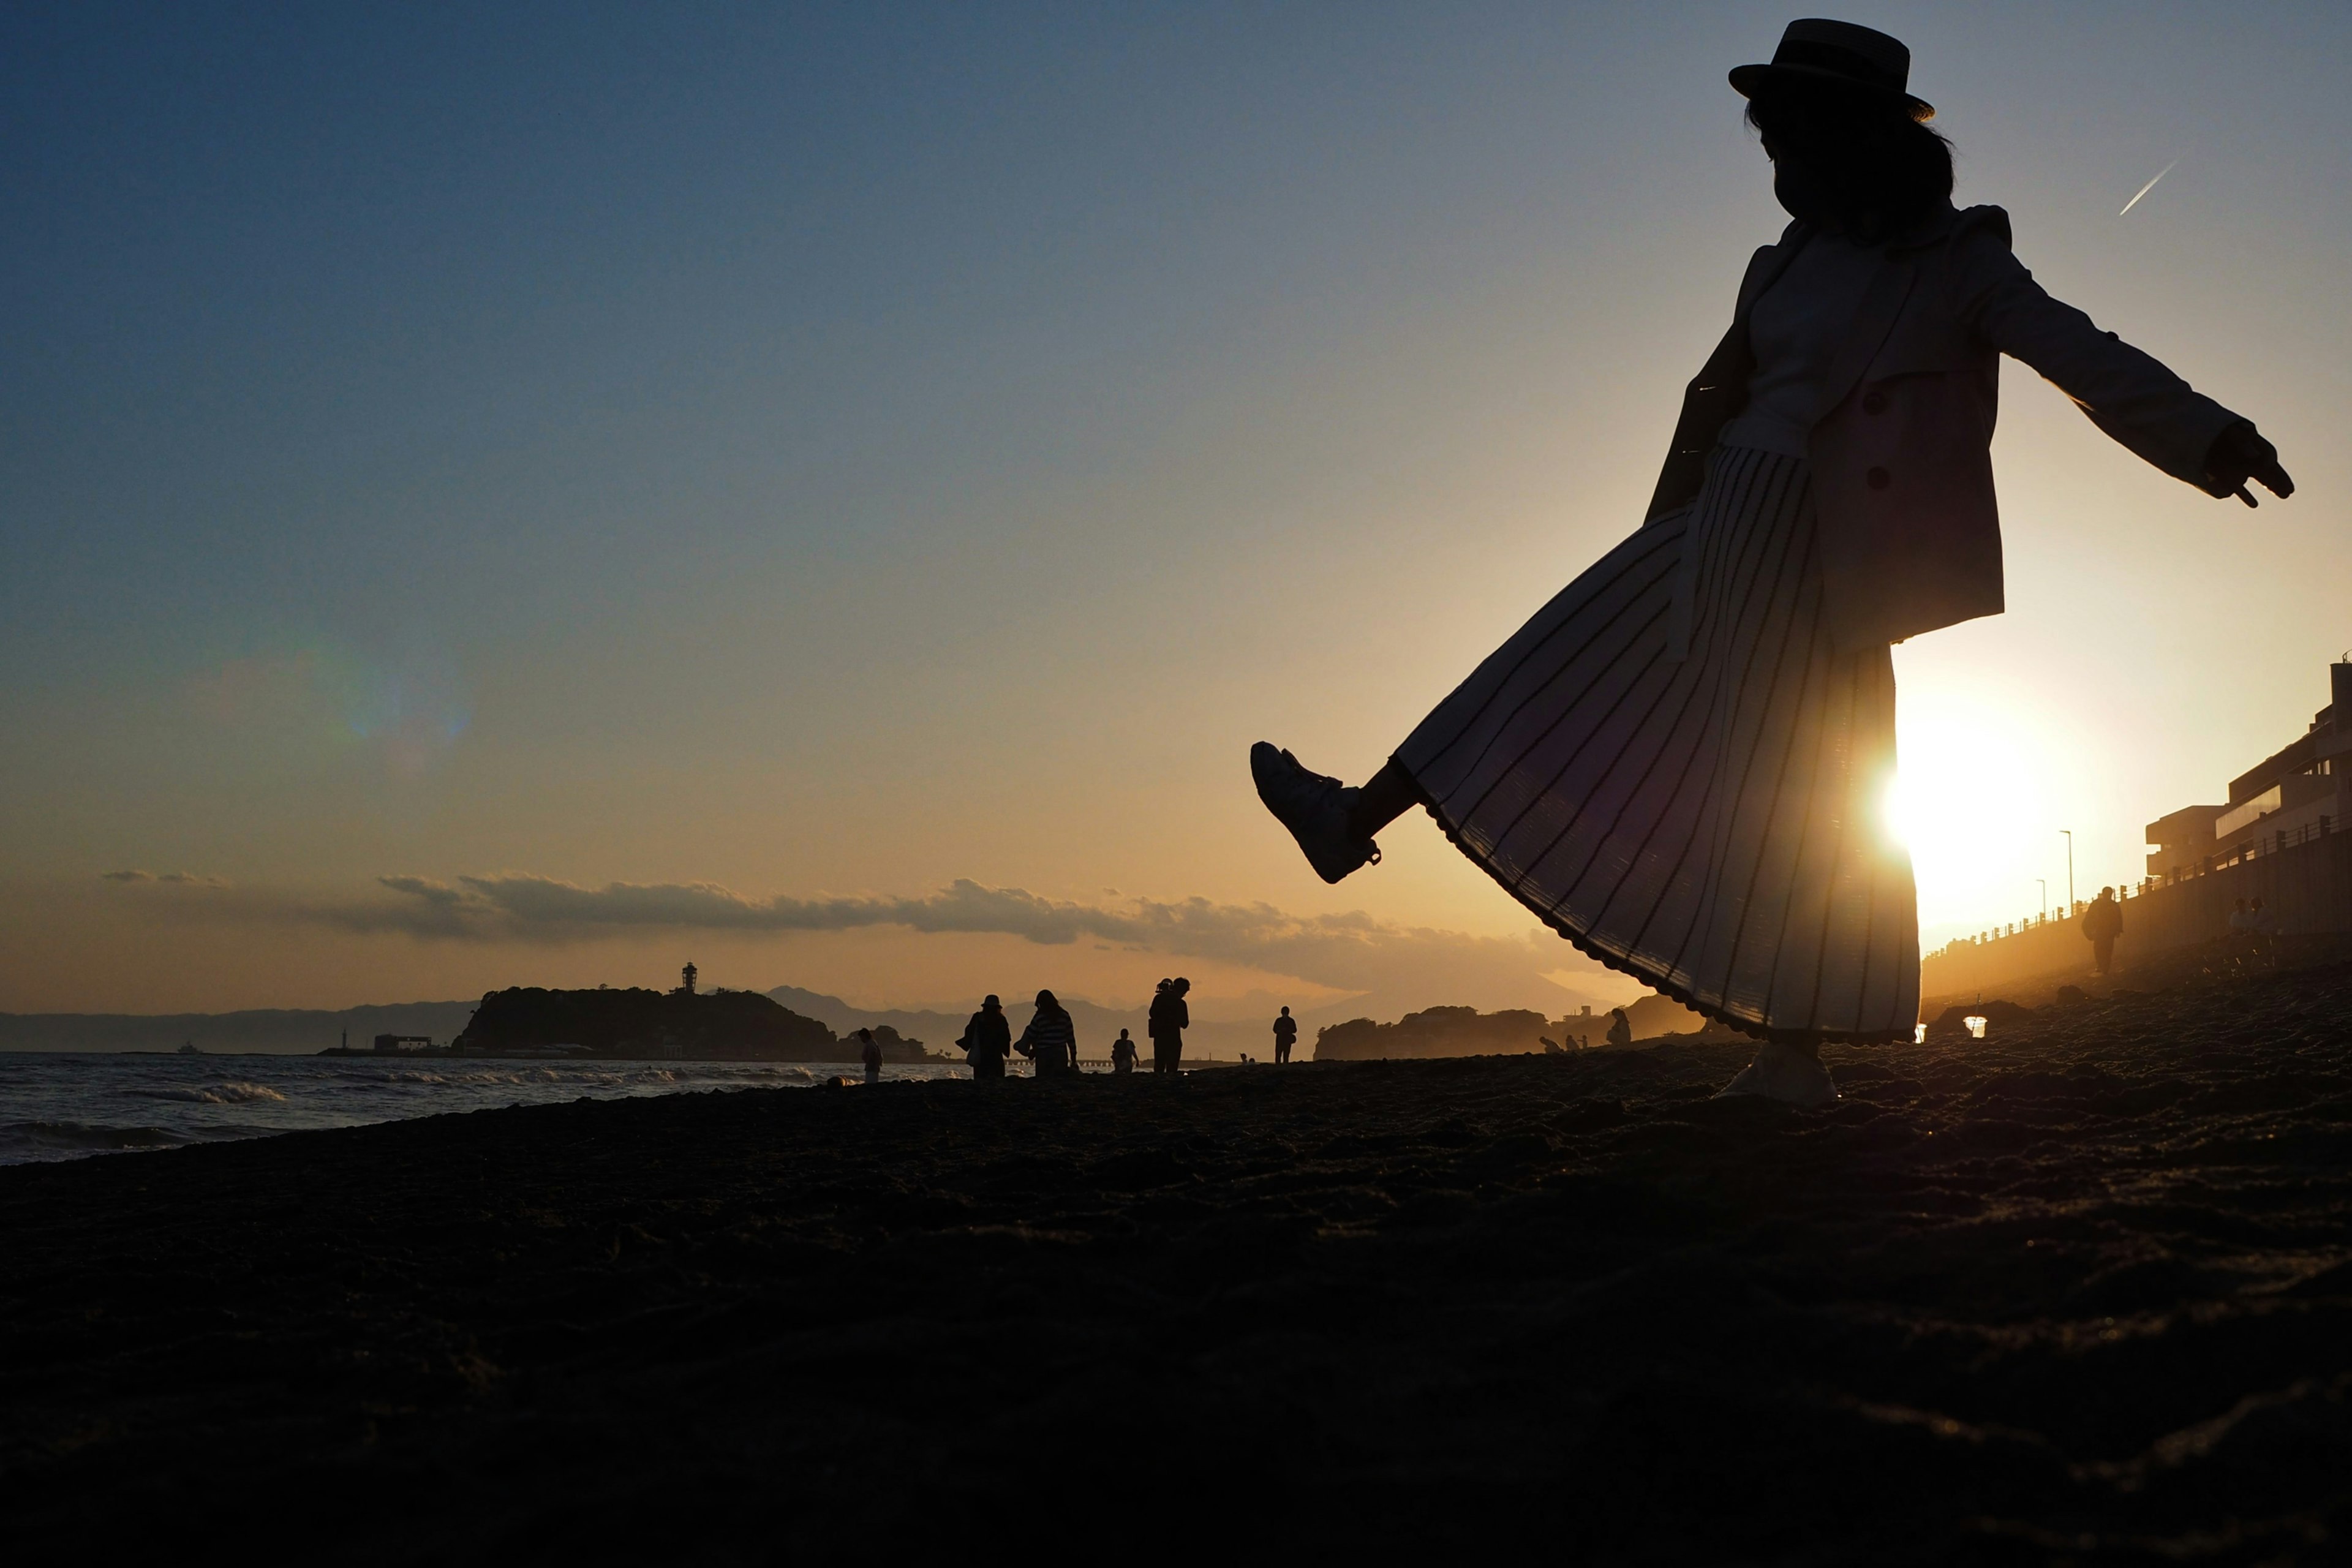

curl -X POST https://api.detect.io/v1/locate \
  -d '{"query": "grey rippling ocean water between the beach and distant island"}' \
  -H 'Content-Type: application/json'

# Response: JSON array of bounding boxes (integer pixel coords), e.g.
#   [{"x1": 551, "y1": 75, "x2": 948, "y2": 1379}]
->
[{"x1": 0, "y1": 1051, "x2": 967, "y2": 1166}]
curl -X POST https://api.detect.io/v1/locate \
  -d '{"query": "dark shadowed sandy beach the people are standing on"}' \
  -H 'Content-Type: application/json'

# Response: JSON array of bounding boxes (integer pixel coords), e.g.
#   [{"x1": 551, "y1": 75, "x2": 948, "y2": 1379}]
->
[{"x1": 0, "y1": 968, "x2": 2352, "y2": 1563}]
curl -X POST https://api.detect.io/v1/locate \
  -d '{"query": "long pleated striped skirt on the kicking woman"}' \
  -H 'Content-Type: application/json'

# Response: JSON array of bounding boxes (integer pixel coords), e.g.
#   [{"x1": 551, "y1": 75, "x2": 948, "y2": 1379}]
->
[{"x1": 1397, "y1": 447, "x2": 1919, "y2": 1041}]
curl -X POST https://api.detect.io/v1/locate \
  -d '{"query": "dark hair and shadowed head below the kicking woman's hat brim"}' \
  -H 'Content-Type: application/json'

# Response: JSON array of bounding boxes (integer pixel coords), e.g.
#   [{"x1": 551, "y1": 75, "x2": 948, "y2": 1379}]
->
[{"x1": 1747, "y1": 87, "x2": 1952, "y2": 242}]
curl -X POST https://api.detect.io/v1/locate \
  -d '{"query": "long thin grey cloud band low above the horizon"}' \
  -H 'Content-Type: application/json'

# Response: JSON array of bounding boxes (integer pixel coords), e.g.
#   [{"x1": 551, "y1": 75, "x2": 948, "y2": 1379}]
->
[{"x1": 110, "y1": 872, "x2": 1618, "y2": 997}]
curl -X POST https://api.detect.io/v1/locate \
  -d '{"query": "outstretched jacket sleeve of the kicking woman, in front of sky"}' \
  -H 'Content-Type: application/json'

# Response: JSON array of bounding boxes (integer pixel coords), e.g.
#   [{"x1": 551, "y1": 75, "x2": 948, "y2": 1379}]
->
[{"x1": 1952, "y1": 207, "x2": 2239, "y2": 496}]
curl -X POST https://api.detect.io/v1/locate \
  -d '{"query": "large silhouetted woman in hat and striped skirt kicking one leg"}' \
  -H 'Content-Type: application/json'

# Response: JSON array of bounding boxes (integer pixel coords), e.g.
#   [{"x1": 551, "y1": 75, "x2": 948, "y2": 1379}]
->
[{"x1": 1249, "y1": 21, "x2": 2293, "y2": 1105}]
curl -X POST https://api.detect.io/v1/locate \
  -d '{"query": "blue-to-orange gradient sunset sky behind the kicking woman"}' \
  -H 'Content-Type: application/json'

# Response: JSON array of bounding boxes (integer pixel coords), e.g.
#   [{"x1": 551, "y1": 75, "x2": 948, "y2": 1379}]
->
[{"x1": 0, "y1": 2, "x2": 2352, "y2": 1016}]
